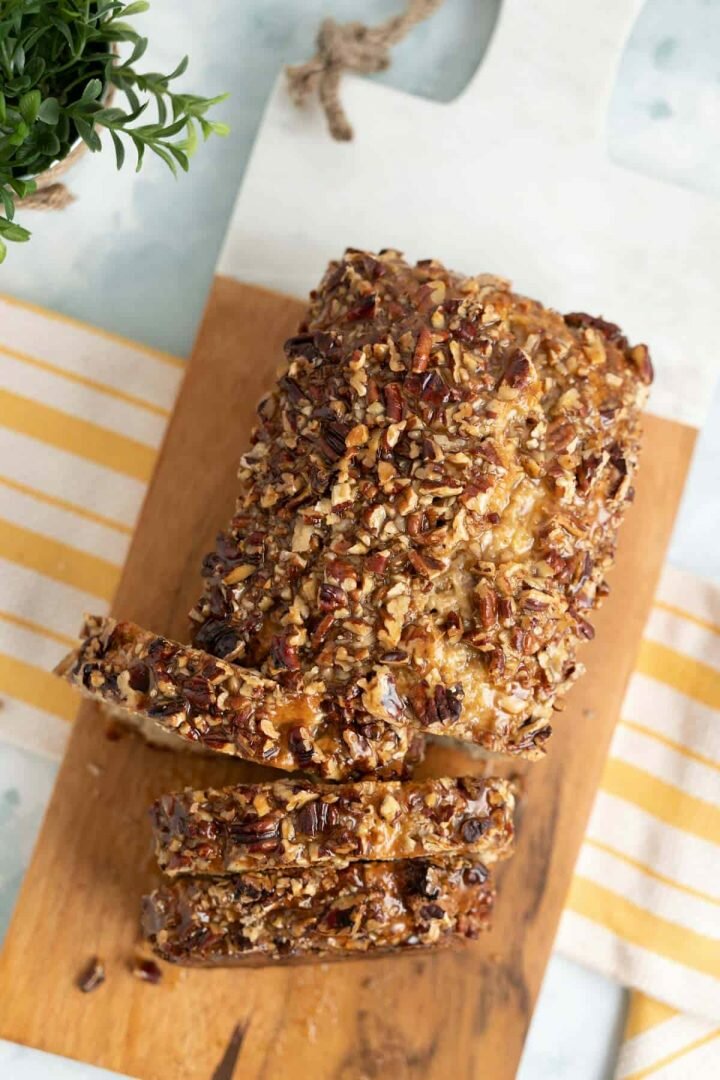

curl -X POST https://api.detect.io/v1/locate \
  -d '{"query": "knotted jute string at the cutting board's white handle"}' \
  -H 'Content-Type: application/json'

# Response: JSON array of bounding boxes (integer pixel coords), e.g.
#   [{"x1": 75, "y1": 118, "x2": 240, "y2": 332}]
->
[{"x1": 286, "y1": 0, "x2": 443, "y2": 141}]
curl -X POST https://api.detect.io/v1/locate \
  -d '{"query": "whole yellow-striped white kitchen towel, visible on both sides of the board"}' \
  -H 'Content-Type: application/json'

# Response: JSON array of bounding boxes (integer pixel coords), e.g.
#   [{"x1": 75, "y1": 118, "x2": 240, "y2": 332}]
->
[{"x1": 0, "y1": 297, "x2": 720, "y2": 1080}]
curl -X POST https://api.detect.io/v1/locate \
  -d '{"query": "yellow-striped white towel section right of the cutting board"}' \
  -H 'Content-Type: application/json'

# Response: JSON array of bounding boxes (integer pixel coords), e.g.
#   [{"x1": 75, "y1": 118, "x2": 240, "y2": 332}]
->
[{"x1": 557, "y1": 568, "x2": 720, "y2": 1080}]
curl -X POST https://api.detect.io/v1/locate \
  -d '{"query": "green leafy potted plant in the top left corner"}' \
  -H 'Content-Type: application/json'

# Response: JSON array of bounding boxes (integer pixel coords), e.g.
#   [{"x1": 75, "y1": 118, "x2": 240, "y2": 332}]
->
[{"x1": 0, "y1": 0, "x2": 228, "y2": 262}]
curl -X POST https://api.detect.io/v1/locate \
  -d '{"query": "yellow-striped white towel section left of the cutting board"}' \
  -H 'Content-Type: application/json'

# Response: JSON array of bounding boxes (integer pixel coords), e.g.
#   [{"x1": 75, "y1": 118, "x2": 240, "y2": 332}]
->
[{"x1": 0, "y1": 296, "x2": 184, "y2": 757}]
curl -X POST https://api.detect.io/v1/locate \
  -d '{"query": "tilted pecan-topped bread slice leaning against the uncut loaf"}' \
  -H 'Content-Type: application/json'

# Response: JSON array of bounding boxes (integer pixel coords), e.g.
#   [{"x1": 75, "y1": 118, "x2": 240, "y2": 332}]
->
[{"x1": 55, "y1": 617, "x2": 424, "y2": 780}]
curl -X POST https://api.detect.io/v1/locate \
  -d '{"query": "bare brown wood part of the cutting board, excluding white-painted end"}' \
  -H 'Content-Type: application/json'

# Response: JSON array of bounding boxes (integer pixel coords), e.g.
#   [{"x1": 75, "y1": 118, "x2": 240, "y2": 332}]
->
[{"x1": 0, "y1": 278, "x2": 695, "y2": 1080}]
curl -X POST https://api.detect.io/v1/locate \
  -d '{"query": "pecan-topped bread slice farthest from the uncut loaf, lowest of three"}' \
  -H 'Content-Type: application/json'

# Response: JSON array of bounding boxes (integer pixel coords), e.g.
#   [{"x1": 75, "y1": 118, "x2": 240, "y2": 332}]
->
[{"x1": 142, "y1": 859, "x2": 493, "y2": 967}]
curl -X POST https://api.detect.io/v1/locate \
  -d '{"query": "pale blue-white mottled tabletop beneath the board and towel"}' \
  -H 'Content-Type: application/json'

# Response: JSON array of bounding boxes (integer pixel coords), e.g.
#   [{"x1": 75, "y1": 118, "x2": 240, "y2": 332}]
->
[{"x1": 0, "y1": 0, "x2": 720, "y2": 1080}]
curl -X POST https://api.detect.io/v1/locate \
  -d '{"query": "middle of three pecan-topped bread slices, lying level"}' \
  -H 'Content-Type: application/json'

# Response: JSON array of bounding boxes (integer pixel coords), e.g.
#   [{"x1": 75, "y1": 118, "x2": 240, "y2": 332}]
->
[{"x1": 151, "y1": 777, "x2": 514, "y2": 876}]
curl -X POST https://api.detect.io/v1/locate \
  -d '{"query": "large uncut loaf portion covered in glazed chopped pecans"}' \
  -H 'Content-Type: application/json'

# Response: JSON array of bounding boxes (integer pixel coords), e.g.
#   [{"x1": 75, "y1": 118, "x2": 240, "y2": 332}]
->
[{"x1": 188, "y1": 251, "x2": 652, "y2": 754}]
